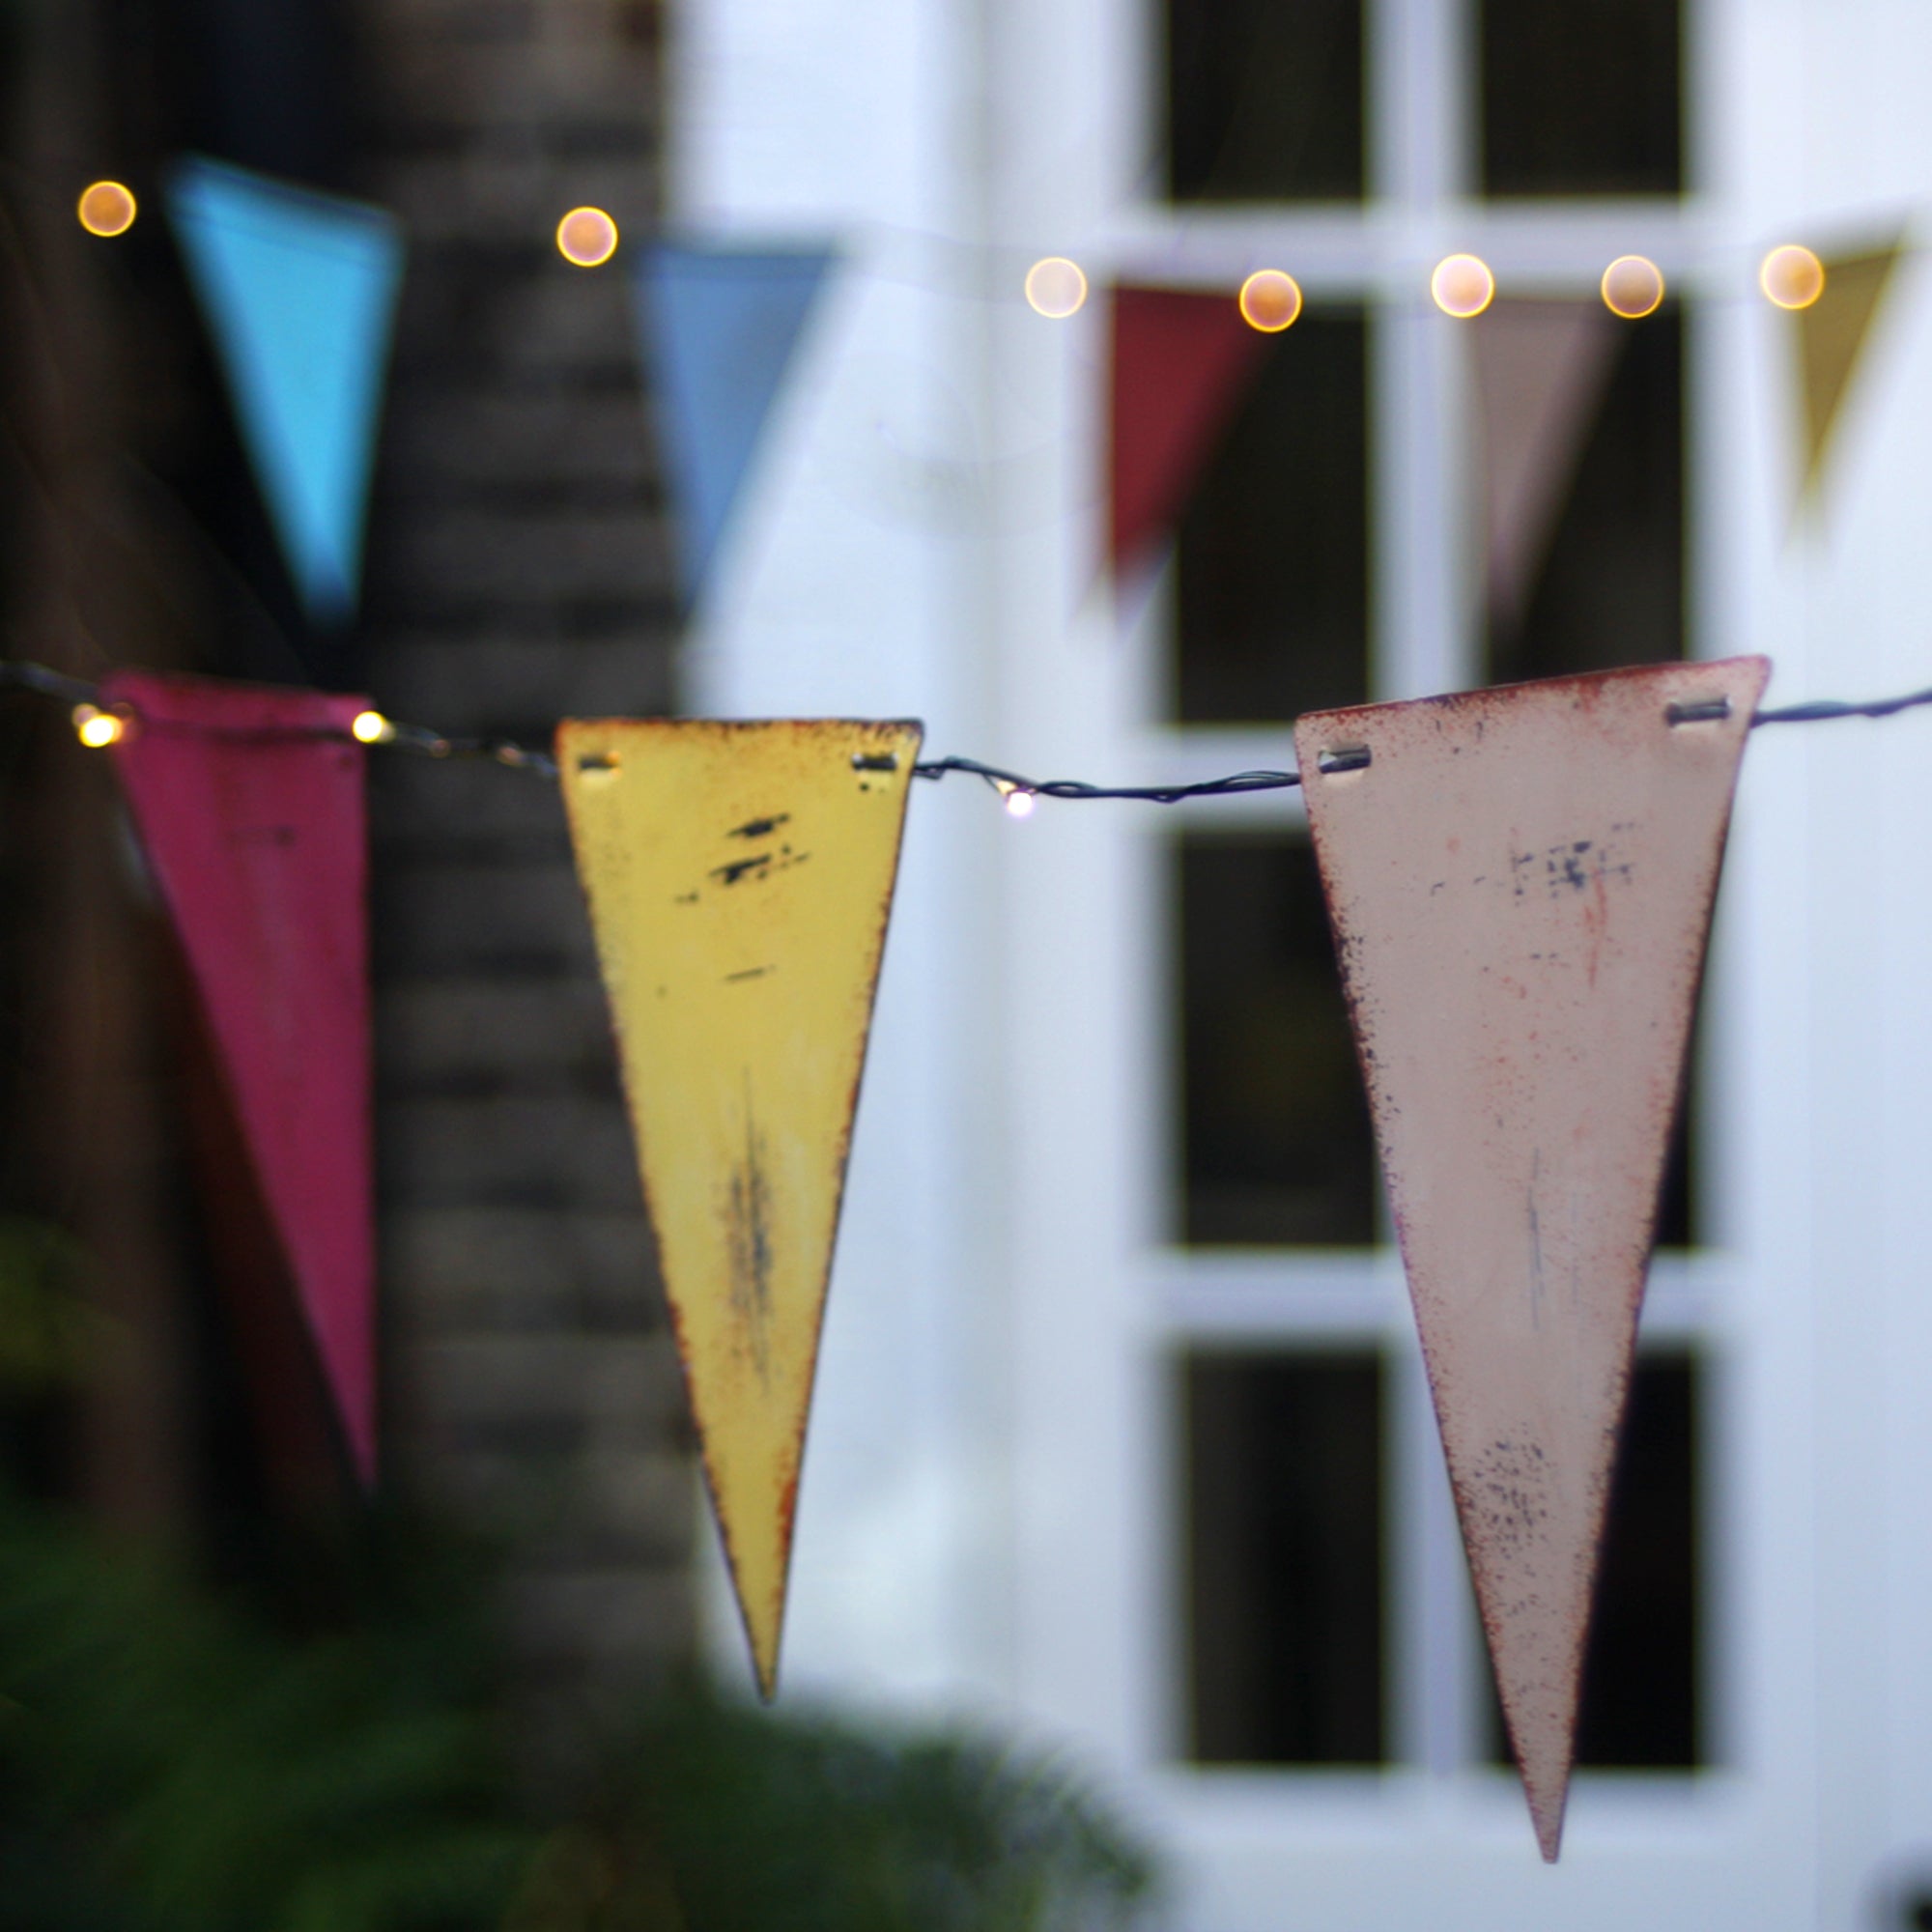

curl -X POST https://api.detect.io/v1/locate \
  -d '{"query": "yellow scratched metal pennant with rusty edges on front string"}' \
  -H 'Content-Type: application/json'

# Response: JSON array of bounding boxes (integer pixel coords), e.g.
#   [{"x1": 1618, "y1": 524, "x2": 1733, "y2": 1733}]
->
[{"x1": 556, "y1": 719, "x2": 920, "y2": 1698}]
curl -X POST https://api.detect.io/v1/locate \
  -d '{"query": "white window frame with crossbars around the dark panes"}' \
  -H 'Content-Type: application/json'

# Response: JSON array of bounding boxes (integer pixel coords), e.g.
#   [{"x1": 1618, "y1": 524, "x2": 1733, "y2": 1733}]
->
[{"x1": 995, "y1": 0, "x2": 1832, "y2": 1926}]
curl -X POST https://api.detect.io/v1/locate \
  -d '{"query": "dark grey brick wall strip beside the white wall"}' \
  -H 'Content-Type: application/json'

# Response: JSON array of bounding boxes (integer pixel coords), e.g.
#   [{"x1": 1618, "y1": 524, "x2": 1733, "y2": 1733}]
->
[{"x1": 361, "y1": 0, "x2": 694, "y2": 1685}]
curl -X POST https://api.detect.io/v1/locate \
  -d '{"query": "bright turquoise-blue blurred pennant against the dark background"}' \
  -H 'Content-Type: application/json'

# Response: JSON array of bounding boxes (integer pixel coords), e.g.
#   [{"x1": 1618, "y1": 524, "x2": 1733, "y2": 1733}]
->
[{"x1": 168, "y1": 156, "x2": 402, "y2": 624}]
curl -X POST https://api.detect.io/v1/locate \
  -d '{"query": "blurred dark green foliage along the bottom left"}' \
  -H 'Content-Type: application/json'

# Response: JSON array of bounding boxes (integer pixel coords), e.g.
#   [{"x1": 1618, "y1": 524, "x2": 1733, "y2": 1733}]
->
[{"x1": 0, "y1": 1497, "x2": 1148, "y2": 1932}]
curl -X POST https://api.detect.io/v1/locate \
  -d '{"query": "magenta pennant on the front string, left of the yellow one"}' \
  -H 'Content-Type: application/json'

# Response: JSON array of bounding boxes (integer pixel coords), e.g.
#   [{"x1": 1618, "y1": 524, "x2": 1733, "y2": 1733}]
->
[{"x1": 102, "y1": 670, "x2": 375, "y2": 1482}]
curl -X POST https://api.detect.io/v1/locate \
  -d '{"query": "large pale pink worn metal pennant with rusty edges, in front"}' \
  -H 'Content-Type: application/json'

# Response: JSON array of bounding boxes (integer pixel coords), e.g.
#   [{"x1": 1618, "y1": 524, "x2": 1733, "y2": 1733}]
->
[{"x1": 1294, "y1": 657, "x2": 1770, "y2": 1859}]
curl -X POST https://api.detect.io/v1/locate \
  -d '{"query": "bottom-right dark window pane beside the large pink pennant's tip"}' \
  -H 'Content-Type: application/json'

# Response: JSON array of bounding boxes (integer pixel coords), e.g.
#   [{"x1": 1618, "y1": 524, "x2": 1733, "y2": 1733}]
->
[{"x1": 1490, "y1": 1354, "x2": 1706, "y2": 1770}]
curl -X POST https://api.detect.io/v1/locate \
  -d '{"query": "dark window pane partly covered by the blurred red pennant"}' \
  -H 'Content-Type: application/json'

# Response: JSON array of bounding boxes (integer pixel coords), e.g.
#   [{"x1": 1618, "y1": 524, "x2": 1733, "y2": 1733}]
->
[{"x1": 1175, "y1": 309, "x2": 1368, "y2": 724}]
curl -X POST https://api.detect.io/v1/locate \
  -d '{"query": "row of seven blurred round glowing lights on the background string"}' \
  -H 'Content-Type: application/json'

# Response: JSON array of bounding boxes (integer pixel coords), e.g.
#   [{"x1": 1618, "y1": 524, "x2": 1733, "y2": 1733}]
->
[{"x1": 75, "y1": 182, "x2": 1826, "y2": 336}]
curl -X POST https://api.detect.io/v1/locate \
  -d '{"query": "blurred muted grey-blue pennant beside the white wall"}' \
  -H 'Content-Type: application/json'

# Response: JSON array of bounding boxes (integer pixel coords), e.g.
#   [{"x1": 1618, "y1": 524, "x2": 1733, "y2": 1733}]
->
[{"x1": 636, "y1": 243, "x2": 833, "y2": 603}]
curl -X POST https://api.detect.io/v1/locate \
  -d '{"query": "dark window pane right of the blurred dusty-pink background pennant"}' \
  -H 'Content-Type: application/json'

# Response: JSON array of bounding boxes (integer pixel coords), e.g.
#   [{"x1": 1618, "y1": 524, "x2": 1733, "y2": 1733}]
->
[{"x1": 1470, "y1": 307, "x2": 1685, "y2": 684}]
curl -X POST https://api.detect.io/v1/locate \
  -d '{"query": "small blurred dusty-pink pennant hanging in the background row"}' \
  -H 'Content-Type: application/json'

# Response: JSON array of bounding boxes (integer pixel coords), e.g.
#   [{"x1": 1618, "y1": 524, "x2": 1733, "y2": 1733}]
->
[{"x1": 1466, "y1": 299, "x2": 1629, "y2": 630}]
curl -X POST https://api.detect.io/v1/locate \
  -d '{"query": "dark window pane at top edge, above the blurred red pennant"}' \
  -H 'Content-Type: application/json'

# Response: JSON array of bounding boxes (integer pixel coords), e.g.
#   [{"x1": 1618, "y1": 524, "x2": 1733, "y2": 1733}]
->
[{"x1": 1167, "y1": 0, "x2": 1362, "y2": 201}]
